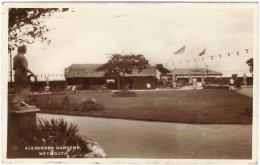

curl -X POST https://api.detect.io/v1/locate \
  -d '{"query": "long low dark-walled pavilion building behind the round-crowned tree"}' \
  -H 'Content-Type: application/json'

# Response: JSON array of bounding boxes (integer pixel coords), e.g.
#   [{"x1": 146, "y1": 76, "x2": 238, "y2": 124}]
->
[{"x1": 64, "y1": 64, "x2": 157, "y2": 89}]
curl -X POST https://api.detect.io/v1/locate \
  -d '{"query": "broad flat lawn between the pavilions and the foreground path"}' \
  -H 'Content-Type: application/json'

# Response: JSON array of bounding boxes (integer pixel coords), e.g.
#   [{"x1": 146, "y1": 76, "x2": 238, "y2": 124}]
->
[{"x1": 30, "y1": 89, "x2": 253, "y2": 124}]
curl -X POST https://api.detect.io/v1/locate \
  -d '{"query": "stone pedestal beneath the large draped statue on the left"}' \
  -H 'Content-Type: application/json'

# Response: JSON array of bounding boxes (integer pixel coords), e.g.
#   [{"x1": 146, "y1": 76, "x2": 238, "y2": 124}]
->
[{"x1": 7, "y1": 106, "x2": 40, "y2": 158}]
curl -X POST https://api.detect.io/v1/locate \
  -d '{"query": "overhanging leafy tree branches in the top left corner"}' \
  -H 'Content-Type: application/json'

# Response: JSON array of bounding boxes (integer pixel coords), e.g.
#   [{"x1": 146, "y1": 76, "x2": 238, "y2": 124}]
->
[{"x1": 8, "y1": 8, "x2": 69, "y2": 81}]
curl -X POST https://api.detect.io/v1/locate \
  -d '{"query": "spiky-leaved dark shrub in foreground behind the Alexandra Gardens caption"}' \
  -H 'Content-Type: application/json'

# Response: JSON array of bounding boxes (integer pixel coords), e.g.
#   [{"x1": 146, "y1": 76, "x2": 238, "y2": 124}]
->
[{"x1": 18, "y1": 118, "x2": 106, "y2": 158}]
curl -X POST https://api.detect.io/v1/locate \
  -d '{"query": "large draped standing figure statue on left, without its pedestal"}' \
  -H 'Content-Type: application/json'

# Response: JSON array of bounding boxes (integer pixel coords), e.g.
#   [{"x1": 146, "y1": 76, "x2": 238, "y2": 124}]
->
[{"x1": 11, "y1": 46, "x2": 37, "y2": 110}]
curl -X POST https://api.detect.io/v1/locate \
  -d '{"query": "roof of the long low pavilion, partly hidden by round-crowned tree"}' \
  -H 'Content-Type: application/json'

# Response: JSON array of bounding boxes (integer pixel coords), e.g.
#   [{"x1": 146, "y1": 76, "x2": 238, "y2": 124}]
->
[{"x1": 65, "y1": 64, "x2": 156, "y2": 78}]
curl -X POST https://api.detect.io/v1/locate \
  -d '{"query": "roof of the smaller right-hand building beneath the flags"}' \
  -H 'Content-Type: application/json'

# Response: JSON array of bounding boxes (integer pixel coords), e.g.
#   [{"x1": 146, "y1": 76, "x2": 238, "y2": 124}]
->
[{"x1": 171, "y1": 68, "x2": 223, "y2": 76}]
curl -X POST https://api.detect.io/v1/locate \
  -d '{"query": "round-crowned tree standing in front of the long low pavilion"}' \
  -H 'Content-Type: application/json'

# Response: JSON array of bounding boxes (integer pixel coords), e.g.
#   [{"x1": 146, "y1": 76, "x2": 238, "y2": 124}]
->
[{"x1": 96, "y1": 54, "x2": 149, "y2": 88}]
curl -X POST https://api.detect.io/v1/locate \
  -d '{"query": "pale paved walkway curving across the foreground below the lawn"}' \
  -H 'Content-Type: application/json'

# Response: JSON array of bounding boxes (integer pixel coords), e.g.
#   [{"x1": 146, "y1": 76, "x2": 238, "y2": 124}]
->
[{"x1": 37, "y1": 114, "x2": 252, "y2": 159}]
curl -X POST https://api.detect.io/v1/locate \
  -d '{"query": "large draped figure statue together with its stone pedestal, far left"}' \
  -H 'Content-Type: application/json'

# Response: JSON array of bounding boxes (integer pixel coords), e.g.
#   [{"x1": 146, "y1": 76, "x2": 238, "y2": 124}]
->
[{"x1": 7, "y1": 46, "x2": 40, "y2": 156}]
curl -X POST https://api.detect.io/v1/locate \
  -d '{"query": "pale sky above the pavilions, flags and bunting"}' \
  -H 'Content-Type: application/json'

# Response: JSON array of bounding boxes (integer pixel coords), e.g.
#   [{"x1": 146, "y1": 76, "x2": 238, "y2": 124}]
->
[{"x1": 6, "y1": 3, "x2": 258, "y2": 80}]
